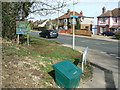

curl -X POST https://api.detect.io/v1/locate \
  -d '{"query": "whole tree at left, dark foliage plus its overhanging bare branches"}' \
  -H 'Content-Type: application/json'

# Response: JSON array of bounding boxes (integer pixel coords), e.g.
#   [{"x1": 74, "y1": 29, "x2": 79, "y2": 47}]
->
[{"x1": 2, "y1": 0, "x2": 66, "y2": 39}]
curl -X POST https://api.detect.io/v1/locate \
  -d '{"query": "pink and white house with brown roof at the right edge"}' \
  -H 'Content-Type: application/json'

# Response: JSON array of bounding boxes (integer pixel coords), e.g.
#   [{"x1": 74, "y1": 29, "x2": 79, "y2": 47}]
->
[{"x1": 97, "y1": 7, "x2": 120, "y2": 34}]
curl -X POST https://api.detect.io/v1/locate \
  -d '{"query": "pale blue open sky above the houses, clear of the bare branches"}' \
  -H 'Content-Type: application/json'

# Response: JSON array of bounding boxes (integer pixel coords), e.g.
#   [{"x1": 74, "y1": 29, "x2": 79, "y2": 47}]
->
[{"x1": 29, "y1": 0, "x2": 120, "y2": 24}]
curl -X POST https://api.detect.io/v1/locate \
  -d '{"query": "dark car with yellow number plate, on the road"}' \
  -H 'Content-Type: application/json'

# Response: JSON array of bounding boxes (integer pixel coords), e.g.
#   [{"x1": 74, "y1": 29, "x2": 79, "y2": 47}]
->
[{"x1": 39, "y1": 29, "x2": 58, "y2": 38}]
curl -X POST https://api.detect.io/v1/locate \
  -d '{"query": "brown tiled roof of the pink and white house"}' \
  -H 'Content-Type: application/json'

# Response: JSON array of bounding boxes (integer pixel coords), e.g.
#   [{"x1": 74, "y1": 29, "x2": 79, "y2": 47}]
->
[{"x1": 98, "y1": 8, "x2": 120, "y2": 17}]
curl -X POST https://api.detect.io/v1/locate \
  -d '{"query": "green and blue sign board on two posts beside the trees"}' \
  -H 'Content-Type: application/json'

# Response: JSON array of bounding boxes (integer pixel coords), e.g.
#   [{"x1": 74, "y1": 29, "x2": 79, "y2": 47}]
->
[{"x1": 16, "y1": 21, "x2": 31, "y2": 34}]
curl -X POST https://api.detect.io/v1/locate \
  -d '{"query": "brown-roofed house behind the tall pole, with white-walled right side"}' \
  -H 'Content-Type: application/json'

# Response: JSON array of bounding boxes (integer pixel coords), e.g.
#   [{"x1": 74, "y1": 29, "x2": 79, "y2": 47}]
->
[{"x1": 57, "y1": 9, "x2": 94, "y2": 33}]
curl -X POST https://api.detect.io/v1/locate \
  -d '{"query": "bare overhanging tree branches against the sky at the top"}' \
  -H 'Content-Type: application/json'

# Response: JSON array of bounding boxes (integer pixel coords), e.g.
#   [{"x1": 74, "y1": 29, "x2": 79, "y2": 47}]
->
[{"x1": 29, "y1": 0, "x2": 67, "y2": 16}]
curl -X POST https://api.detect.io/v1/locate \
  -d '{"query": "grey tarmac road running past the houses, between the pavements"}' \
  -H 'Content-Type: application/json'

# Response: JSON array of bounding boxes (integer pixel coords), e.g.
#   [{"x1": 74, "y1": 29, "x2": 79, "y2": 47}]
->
[{"x1": 30, "y1": 31, "x2": 119, "y2": 58}]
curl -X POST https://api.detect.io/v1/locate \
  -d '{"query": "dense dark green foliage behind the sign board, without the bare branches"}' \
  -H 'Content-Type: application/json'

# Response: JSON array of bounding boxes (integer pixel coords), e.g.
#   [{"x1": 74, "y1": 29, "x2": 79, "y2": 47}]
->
[{"x1": 2, "y1": 2, "x2": 32, "y2": 39}]
